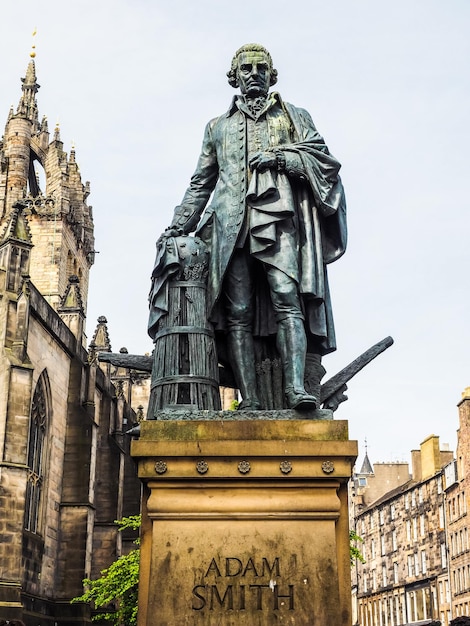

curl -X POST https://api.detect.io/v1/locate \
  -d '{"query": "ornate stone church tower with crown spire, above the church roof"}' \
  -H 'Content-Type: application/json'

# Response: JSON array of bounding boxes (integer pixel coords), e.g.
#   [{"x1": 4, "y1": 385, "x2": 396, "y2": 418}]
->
[{"x1": 0, "y1": 54, "x2": 95, "y2": 315}]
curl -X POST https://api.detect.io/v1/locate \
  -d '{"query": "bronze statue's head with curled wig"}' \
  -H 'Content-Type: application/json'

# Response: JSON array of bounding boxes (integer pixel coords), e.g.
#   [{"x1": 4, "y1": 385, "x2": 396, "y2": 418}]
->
[{"x1": 227, "y1": 43, "x2": 277, "y2": 96}]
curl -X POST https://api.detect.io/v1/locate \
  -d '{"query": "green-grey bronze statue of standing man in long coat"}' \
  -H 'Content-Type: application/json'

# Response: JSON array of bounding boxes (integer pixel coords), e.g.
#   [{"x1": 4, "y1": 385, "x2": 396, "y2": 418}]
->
[{"x1": 149, "y1": 44, "x2": 346, "y2": 410}]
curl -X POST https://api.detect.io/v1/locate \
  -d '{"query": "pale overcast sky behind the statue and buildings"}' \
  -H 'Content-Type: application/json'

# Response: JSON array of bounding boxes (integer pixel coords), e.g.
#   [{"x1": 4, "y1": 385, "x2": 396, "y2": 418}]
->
[{"x1": 0, "y1": 0, "x2": 470, "y2": 462}]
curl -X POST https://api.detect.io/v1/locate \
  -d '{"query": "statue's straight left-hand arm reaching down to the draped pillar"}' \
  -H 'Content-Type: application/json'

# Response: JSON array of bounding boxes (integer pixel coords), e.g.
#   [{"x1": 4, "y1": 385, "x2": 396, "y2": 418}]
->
[{"x1": 170, "y1": 121, "x2": 219, "y2": 234}]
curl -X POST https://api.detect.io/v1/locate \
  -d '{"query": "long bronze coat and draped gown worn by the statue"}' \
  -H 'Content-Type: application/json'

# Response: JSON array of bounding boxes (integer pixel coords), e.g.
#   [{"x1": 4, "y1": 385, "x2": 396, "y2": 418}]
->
[{"x1": 149, "y1": 93, "x2": 347, "y2": 354}]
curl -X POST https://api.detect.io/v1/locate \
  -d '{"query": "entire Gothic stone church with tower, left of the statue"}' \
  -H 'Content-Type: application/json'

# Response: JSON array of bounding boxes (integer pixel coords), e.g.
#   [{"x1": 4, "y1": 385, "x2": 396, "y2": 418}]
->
[{"x1": 0, "y1": 60, "x2": 148, "y2": 626}]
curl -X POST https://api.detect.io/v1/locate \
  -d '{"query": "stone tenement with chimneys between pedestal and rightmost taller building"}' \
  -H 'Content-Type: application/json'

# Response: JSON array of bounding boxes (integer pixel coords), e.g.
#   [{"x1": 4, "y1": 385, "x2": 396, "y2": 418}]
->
[{"x1": 351, "y1": 435, "x2": 453, "y2": 626}]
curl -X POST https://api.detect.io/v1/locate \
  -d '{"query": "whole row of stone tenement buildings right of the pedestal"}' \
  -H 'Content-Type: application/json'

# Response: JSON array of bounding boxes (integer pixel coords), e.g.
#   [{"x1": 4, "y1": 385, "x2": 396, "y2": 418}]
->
[{"x1": 350, "y1": 388, "x2": 470, "y2": 626}]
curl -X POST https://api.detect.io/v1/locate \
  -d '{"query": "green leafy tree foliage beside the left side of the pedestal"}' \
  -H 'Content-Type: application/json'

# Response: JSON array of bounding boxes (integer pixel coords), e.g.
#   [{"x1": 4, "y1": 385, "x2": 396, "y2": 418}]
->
[{"x1": 72, "y1": 515, "x2": 141, "y2": 626}]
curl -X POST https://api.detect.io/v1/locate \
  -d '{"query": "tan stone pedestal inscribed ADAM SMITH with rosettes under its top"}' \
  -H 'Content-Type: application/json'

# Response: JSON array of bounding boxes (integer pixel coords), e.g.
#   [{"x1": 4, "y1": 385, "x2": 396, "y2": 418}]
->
[{"x1": 132, "y1": 411, "x2": 357, "y2": 626}]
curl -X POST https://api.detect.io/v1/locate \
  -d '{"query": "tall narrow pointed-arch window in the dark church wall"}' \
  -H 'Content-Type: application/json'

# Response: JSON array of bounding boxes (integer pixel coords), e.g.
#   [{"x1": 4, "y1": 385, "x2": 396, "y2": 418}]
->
[{"x1": 24, "y1": 372, "x2": 50, "y2": 533}]
